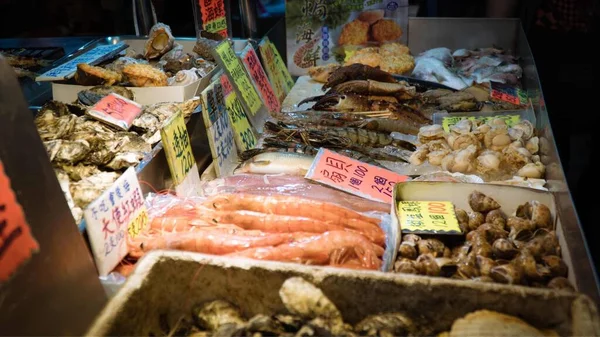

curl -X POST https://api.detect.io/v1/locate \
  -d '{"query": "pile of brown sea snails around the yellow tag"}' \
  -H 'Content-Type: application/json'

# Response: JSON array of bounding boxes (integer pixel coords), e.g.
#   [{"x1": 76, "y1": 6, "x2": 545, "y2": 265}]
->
[{"x1": 394, "y1": 191, "x2": 573, "y2": 290}]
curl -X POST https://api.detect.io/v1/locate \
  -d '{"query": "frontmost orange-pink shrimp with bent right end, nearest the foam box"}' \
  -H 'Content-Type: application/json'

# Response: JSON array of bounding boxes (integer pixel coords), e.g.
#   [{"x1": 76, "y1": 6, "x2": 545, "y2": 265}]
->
[{"x1": 229, "y1": 231, "x2": 384, "y2": 269}]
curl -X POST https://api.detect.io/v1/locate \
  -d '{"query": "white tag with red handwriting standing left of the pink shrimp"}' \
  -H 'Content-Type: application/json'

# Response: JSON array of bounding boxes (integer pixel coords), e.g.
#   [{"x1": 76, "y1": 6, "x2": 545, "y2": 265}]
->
[{"x1": 83, "y1": 167, "x2": 148, "y2": 276}]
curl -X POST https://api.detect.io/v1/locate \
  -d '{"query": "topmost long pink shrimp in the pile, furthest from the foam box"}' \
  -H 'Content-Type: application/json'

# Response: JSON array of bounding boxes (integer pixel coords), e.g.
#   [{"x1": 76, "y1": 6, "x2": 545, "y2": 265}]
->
[{"x1": 204, "y1": 193, "x2": 379, "y2": 226}]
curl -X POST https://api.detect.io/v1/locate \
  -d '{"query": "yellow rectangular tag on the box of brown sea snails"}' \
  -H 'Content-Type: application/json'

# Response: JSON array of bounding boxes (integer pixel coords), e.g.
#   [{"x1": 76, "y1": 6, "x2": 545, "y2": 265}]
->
[{"x1": 398, "y1": 201, "x2": 462, "y2": 234}]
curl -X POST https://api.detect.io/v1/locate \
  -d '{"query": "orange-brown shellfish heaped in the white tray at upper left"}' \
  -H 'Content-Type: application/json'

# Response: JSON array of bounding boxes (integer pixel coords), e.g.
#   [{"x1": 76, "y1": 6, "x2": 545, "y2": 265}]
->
[{"x1": 74, "y1": 23, "x2": 216, "y2": 87}]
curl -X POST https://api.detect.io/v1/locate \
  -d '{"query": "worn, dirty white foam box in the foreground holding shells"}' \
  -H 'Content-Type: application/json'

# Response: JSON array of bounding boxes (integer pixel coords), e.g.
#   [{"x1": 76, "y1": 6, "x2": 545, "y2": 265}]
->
[{"x1": 87, "y1": 251, "x2": 600, "y2": 336}]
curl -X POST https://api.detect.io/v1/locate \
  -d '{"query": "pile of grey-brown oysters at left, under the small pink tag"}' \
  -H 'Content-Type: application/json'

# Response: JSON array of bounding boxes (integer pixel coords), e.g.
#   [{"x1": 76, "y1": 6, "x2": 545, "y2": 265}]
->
[{"x1": 35, "y1": 96, "x2": 200, "y2": 222}]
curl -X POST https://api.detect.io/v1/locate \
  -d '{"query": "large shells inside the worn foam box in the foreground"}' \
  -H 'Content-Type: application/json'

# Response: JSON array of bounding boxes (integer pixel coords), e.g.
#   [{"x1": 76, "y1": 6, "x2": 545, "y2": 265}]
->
[{"x1": 161, "y1": 277, "x2": 544, "y2": 337}]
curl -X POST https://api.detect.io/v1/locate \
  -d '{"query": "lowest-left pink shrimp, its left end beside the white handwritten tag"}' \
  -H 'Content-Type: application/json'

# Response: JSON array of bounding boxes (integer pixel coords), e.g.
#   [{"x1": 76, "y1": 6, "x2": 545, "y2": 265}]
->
[{"x1": 128, "y1": 229, "x2": 314, "y2": 257}]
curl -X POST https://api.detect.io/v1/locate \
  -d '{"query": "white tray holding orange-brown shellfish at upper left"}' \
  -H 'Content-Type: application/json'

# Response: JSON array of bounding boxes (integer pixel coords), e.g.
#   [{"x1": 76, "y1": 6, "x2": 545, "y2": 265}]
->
[{"x1": 52, "y1": 38, "x2": 220, "y2": 105}]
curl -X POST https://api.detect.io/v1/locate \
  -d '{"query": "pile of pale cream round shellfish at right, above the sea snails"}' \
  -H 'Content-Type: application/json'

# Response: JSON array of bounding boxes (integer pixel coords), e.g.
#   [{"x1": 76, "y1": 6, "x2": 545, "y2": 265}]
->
[{"x1": 410, "y1": 118, "x2": 546, "y2": 180}]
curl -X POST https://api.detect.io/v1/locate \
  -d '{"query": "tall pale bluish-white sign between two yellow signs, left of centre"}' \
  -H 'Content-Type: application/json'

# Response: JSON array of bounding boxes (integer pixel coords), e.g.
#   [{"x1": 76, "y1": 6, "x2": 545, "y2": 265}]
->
[{"x1": 201, "y1": 82, "x2": 239, "y2": 177}]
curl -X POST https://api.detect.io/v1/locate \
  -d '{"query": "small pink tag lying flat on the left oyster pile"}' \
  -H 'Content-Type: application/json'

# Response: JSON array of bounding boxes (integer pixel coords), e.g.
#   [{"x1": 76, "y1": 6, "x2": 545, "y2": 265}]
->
[{"x1": 87, "y1": 93, "x2": 142, "y2": 130}]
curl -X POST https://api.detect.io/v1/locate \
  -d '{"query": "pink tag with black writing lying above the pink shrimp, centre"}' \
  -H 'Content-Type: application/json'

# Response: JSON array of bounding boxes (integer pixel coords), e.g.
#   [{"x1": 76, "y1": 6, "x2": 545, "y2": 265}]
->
[{"x1": 305, "y1": 148, "x2": 408, "y2": 202}]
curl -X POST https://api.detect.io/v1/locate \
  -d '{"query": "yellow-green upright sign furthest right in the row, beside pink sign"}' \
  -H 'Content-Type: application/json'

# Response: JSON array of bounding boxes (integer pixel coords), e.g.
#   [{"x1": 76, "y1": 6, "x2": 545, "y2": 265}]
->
[{"x1": 258, "y1": 37, "x2": 294, "y2": 102}]
